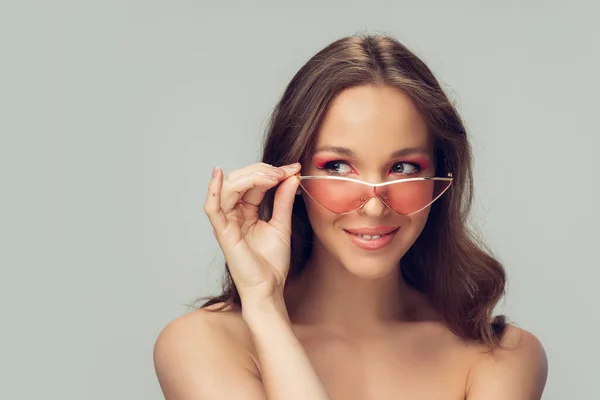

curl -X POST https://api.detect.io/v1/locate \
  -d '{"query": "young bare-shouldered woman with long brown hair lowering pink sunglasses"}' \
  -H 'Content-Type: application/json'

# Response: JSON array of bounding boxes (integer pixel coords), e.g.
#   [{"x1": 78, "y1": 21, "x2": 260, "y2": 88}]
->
[{"x1": 154, "y1": 35, "x2": 547, "y2": 400}]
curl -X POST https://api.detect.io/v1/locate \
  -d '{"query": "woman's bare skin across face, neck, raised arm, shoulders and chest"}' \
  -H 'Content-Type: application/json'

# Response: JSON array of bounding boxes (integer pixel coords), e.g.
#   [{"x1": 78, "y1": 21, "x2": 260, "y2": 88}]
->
[{"x1": 155, "y1": 86, "x2": 547, "y2": 400}]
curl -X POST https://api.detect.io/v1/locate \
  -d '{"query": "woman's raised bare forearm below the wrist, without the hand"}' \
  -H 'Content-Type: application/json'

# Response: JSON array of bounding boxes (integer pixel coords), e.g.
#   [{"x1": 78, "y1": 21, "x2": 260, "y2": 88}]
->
[{"x1": 242, "y1": 299, "x2": 330, "y2": 400}]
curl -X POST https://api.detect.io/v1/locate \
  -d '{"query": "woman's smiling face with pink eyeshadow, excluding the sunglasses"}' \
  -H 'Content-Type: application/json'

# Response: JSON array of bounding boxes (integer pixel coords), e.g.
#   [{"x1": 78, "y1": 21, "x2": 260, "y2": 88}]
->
[{"x1": 301, "y1": 85, "x2": 435, "y2": 278}]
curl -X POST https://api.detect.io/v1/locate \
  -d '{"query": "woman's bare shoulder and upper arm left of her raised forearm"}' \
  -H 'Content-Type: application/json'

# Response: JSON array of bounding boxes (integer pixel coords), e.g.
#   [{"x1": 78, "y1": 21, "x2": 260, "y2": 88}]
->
[{"x1": 154, "y1": 305, "x2": 263, "y2": 400}]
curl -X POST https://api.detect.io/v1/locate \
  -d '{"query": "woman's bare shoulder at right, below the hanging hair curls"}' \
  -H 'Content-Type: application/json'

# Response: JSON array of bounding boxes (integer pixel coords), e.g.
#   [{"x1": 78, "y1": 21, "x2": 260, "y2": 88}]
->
[{"x1": 467, "y1": 325, "x2": 548, "y2": 400}]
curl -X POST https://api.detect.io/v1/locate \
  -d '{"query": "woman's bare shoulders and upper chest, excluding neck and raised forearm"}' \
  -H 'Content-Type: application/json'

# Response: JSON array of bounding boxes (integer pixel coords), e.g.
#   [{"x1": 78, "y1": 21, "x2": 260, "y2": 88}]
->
[{"x1": 158, "y1": 305, "x2": 545, "y2": 400}]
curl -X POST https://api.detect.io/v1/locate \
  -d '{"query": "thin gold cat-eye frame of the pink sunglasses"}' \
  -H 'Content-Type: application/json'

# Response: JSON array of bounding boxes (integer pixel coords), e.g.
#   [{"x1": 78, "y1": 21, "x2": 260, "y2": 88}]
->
[{"x1": 296, "y1": 173, "x2": 454, "y2": 217}]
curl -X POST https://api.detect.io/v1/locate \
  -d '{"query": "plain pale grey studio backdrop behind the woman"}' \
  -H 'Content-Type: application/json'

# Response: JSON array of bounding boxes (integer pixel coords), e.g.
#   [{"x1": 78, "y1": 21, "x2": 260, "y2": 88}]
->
[{"x1": 25, "y1": 0, "x2": 600, "y2": 400}]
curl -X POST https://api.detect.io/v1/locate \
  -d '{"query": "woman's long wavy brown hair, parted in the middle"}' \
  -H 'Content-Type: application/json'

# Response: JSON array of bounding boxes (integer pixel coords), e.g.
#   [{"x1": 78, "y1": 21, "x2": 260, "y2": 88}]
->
[{"x1": 199, "y1": 34, "x2": 507, "y2": 346}]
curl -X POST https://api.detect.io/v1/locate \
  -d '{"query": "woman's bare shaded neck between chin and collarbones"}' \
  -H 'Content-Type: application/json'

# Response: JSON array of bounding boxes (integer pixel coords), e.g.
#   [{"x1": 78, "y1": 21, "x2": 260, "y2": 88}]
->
[{"x1": 285, "y1": 247, "x2": 439, "y2": 331}]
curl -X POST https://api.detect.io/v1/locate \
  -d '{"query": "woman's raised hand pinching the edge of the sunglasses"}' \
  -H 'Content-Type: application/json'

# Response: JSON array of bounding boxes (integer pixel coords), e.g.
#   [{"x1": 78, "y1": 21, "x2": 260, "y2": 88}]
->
[{"x1": 204, "y1": 163, "x2": 300, "y2": 303}]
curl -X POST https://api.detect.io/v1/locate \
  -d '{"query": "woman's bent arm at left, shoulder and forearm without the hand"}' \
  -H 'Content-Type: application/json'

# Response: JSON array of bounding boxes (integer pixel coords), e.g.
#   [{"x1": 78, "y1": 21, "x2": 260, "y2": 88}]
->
[{"x1": 154, "y1": 301, "x2": 329, "y2": 400}]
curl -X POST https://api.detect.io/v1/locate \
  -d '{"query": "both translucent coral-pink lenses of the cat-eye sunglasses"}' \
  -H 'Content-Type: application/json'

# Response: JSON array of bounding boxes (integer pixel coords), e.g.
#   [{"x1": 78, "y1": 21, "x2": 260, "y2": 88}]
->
[{"x1": 300, "y1": 178, "x2": 452, "y2": 215}]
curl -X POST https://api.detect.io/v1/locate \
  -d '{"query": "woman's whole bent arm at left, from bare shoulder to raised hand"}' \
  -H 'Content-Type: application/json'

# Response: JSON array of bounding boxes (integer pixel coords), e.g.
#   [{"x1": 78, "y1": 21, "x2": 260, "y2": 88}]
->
[{"x1": 154, "y1": 163, "x2": 329, "y2": 400}]
